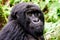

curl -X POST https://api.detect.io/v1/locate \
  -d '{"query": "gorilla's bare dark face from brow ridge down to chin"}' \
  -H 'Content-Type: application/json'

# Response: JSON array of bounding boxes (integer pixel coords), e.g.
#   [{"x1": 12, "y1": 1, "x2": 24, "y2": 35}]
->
[{"x1": 26, "y1": 10, "x2": 44, "y2": 36}]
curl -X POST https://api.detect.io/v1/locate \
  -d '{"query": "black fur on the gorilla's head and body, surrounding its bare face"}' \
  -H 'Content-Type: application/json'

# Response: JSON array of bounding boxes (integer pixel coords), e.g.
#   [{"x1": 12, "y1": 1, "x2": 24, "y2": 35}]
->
[{"x1": 0, "y1": 3, "x2": 44, "y2": 40}]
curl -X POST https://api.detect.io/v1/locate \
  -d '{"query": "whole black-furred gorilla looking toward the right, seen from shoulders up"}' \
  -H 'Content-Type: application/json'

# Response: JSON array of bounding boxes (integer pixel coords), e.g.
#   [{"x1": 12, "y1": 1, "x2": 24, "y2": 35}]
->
[{"x1": 0, "y1": 3, "x2": 44, "y2": 40}]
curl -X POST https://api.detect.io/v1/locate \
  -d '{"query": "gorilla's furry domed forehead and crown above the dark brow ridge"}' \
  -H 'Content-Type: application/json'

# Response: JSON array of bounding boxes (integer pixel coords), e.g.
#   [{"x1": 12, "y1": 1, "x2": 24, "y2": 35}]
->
[{"x1": 14, "y1": 3, "x2": 40, "y2": 12}]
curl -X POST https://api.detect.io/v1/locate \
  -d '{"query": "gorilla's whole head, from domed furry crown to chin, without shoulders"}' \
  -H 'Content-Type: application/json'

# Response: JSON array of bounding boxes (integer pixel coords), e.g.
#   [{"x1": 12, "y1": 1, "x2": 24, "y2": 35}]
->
[{"x1": 9, "y1": 3, "x2": 44, "y2": 36}]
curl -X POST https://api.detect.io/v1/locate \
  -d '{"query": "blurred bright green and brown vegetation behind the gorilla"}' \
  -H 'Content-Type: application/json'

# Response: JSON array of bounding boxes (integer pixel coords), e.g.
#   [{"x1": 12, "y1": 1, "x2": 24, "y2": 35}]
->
[{"x1": 0, "y1": 0, "x2": 60, "y2": 40}]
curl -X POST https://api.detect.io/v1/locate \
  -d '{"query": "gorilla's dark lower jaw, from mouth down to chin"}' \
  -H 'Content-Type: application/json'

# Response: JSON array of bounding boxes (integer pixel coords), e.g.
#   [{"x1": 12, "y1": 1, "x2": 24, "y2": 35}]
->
[{"x1": 23, "y1": 24, "x2": 43, "y2": 37}]
